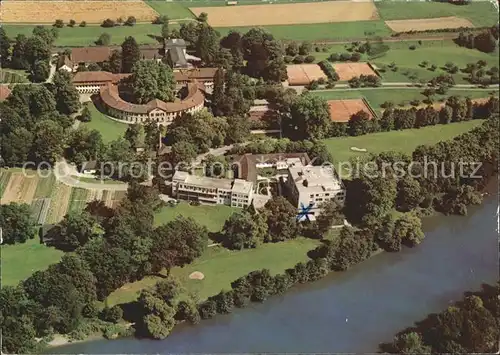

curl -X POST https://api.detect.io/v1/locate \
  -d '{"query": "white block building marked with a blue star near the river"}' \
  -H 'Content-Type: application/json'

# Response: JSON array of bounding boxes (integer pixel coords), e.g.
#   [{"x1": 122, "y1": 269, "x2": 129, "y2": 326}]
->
[{"x1": 287, "y1": 166, "x2": 346, "y2": 220}]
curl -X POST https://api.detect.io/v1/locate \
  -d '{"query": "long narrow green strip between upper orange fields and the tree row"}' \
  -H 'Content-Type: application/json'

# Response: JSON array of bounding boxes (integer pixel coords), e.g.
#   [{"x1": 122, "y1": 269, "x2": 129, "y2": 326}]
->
[{"x1": 312, "y1": 88, "x2": 492, "y2": 113}]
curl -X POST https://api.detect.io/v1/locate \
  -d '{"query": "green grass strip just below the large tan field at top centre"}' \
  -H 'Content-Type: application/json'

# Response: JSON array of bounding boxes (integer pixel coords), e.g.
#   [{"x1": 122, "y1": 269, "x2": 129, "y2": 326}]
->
[{"x1": 217, "y1": 21, "x2": 392, "y2": 41}]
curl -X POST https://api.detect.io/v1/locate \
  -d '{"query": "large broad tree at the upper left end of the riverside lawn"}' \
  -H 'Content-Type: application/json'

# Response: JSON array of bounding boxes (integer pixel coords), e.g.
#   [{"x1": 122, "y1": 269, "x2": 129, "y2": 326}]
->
[{"x1": 151, "y1": 217, "x2": 208, "y2": 271}]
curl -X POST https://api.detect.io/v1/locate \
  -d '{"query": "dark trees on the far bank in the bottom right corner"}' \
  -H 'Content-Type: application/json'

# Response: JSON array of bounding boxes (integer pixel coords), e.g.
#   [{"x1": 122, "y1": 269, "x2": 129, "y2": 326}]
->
[{"x1": 380, "y1": 284, "x2": 500, "y2": 354}]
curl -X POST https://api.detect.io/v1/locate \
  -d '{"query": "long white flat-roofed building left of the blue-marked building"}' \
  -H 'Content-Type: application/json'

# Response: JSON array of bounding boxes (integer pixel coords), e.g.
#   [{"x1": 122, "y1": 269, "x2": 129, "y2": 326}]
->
[{"x1": 172, "y1": 171, "x2": 253, "y2": 208}]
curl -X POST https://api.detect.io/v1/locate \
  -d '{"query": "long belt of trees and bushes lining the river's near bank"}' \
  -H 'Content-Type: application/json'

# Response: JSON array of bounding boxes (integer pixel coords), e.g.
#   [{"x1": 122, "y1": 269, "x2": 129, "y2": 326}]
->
[{"x1": 134, "y1": 117, "x2": 499, "y2": 339}]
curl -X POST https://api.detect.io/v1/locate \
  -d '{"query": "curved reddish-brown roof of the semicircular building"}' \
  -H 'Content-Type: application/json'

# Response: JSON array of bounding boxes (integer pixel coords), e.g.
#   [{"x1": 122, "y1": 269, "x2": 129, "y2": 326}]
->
[{"x1": 100, "y1": 82, "x2": 205, "y2": 114}]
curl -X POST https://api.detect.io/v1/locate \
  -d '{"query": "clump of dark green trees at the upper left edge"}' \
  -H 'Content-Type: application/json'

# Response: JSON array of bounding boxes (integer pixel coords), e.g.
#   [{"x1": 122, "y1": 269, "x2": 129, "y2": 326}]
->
[{"x1": 0, "y1": 26, "x2": 58, "y2": 82}]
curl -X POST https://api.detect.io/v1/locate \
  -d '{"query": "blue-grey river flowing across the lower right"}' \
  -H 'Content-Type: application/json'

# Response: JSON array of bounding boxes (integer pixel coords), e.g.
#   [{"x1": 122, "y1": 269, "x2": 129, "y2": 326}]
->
[{"x1": 50, "y1": 198, "x2": 498, "y2": 354}]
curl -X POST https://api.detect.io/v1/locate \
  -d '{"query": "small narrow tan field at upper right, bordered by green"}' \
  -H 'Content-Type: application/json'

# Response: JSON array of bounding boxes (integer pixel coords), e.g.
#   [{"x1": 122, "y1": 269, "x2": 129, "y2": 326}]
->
[{"x1": 385, "y1": 16, "x2": 474, "y2": 32}]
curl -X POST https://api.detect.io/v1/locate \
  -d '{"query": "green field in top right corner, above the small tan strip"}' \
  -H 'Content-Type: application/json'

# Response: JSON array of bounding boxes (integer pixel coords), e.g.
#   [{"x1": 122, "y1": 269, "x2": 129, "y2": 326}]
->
[{"x1": 375, "y1": 1, "x2": 498, "y2": 26}]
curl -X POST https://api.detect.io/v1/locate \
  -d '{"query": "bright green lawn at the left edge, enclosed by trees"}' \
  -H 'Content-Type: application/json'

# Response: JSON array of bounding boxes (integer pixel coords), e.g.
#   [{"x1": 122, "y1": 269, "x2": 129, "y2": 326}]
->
[{"x1": 1, "y1": 237, "x2": 64, "y2": 286}]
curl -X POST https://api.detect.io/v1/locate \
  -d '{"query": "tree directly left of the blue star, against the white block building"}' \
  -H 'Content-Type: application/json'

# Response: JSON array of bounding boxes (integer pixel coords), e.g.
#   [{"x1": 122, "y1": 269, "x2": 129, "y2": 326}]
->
[{"x1": 263, "y1": 196, "x2": 298, "y2": 242}]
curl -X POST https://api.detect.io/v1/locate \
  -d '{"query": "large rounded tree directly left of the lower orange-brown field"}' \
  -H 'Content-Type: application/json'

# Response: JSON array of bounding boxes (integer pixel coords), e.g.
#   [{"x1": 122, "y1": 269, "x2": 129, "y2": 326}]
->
[{"x1": 283, "y1": 94, "x2": 331, "y2": 140}]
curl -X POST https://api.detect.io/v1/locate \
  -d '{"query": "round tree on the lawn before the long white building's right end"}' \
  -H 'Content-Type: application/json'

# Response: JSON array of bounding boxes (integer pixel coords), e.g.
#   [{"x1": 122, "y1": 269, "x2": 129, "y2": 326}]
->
[{"x1": 221, "y1": 210, "x2": 267, "y2": 250}]
